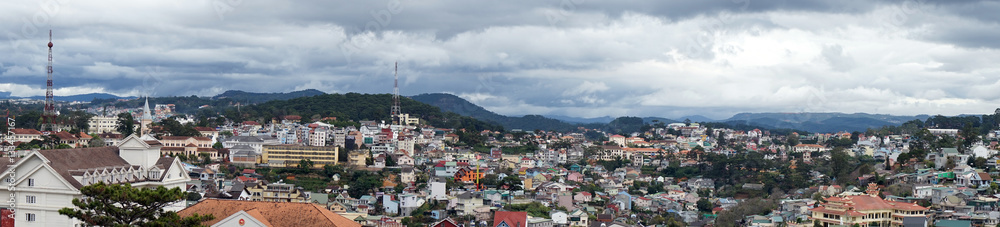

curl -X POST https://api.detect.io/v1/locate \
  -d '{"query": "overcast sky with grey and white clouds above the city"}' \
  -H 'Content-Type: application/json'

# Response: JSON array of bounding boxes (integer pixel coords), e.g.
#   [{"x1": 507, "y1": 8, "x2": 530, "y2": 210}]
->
[{"x1": 0, "y1": 0, "x2": 1000, "y2": 118}]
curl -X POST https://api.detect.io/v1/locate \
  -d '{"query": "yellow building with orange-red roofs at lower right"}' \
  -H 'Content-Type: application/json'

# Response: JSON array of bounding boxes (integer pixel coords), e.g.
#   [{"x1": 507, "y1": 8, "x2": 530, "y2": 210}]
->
[{"x1": 809, "y1": 184, "x2": 927, "y2": 226}]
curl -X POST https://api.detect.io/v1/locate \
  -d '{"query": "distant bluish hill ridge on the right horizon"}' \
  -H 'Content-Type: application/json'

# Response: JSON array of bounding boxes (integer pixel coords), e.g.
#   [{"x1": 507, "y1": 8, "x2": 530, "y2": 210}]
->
[{"x1": 724, "y1": 113, "x2": 928, "y2": 133}]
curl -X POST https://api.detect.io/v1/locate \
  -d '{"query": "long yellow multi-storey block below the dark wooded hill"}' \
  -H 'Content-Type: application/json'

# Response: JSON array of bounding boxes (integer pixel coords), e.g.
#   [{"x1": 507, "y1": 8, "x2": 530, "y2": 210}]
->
[{"x1": 261, "y1": 145, "x2": 340, "y2": 168}]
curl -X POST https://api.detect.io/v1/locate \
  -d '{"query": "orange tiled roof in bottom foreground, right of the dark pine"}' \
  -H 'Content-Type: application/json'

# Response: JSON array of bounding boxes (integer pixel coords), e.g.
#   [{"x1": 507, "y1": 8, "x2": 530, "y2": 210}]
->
[{"x1": 178, "y1": 199, "x2": 361, "y2": 227}]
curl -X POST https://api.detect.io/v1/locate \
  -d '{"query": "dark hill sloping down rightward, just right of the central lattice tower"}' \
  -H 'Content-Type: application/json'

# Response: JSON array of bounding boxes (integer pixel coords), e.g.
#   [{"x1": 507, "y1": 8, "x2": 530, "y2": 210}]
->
[{"x1": 404, "y1": 93, "x2": 577, "y2": 131}]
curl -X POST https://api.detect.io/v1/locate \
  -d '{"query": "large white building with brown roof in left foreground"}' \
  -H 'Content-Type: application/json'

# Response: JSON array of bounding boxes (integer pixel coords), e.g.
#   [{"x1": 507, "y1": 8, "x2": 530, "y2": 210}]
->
[{"x1": 0, "y1": 135, "x2": 189, "y2": 227}]
